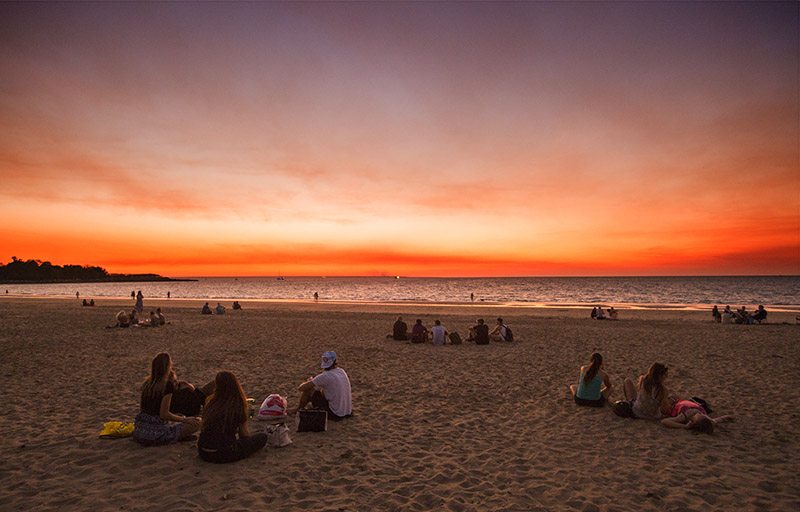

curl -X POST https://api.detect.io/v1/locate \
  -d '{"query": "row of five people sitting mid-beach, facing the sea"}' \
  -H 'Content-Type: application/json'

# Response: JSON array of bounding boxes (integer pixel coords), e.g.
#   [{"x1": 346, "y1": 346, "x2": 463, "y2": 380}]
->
[{"x1": 386, "y1": 316, "x2": 514, "y2": 346}]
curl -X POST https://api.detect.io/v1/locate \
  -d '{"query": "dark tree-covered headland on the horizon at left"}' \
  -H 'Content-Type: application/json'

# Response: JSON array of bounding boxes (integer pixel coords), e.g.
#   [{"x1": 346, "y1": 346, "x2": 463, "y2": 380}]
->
[{"x1": 0, "y1": 256, "x2": 196, "y2": 283}]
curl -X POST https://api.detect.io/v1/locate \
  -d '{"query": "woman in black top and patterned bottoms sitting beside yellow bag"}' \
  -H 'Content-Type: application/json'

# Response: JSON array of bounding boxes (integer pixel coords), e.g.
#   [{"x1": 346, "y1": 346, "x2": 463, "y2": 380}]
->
[{"x1": 133, "y1": 352, "x2": 200, "y2": 445}]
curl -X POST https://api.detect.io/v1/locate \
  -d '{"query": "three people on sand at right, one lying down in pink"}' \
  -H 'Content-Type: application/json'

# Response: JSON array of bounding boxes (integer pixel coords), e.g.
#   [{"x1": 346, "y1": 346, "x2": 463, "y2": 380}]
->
[{"x1": 570, "y1": 352, "x2": 733, "y2": 434}]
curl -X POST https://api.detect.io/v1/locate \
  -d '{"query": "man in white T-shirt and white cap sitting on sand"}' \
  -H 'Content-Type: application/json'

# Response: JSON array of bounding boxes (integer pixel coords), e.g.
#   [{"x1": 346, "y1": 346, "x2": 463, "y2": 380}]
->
[{"x1": 287, "y1": 350, "x2": 353, "y2": 421}]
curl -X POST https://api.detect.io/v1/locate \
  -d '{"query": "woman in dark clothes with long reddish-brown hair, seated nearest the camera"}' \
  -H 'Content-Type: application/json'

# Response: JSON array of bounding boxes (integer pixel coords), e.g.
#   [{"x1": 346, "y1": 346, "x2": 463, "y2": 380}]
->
[{"x1": 197, "y1": 370, "x2": 267, "y2": 464}]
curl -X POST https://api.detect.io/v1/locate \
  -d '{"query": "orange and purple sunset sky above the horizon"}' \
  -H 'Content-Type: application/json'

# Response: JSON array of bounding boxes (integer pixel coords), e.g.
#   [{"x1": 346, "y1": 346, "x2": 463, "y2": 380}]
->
[{"x1": 0, "y1": 2, "x2": 800, "y2": 277}]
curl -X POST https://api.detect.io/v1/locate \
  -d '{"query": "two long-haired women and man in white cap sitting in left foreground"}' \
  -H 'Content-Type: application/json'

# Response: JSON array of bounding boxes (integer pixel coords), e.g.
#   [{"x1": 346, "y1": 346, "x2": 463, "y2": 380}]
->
[{"x1": 133, "y1": 351, "x2": 353, "y2": 463}]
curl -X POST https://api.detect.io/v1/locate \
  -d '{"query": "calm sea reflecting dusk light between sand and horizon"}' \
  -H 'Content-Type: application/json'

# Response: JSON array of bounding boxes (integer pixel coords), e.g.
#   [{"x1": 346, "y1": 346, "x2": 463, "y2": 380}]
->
[{"x1": 0, "y1": 276, "x2": 800, "y2": 310}]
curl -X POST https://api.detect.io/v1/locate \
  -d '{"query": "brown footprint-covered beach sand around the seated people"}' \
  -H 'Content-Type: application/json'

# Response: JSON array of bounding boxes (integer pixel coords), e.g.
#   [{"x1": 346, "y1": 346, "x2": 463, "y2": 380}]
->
[{"x1": 0, "y1": 298, "x2": 800, "y2": 512}]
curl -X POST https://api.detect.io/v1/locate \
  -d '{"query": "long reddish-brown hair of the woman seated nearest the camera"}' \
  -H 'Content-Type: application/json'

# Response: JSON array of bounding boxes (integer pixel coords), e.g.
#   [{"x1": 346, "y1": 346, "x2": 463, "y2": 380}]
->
[{"x1": 203, "y1": 370, "x2": 247, "y2": 434}]
